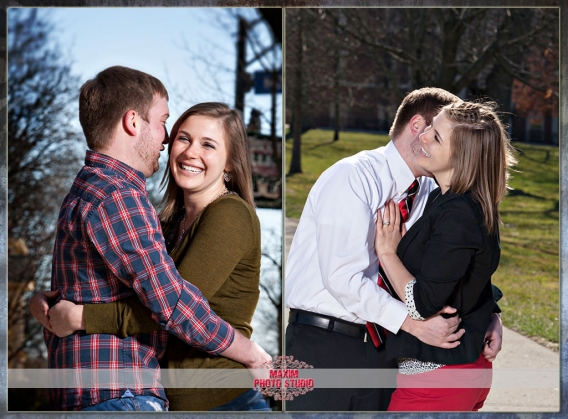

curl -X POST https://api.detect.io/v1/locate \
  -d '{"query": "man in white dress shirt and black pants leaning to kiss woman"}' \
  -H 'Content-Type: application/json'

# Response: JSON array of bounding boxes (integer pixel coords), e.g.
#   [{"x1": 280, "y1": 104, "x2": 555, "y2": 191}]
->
[{"x1": 285, "y1": 88, "x2": 501, "y2": 411}]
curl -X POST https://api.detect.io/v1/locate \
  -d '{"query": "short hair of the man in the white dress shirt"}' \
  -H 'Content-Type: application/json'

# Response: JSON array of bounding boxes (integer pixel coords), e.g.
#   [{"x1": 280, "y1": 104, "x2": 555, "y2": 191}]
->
[{"x1": 389, "y1": 87, "x2": 460, "y2": 140}]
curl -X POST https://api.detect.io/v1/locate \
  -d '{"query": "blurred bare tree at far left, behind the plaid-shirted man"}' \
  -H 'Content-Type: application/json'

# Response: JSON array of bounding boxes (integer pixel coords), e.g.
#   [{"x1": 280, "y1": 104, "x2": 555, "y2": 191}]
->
[{"x1": 8, "y1": 9, "x2": 84, "y2": 368}]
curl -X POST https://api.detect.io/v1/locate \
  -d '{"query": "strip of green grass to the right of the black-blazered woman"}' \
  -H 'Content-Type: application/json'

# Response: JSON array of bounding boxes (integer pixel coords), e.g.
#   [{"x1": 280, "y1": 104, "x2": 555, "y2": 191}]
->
[{"x1": 493, "y1": 143, "x2": 560, "y2": 343}]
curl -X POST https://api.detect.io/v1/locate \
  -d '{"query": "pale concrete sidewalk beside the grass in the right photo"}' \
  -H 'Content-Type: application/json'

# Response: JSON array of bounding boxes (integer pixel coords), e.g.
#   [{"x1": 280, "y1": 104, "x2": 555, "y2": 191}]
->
[{"x1": 286, "y1": 218, "x2": 560, "y2": 412}]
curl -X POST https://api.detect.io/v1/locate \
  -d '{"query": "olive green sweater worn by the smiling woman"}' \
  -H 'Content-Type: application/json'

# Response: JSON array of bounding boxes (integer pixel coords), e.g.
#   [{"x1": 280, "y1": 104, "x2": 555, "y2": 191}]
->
[{"x1": 84, "y1": 194, "x2": 260, "y2": 411}]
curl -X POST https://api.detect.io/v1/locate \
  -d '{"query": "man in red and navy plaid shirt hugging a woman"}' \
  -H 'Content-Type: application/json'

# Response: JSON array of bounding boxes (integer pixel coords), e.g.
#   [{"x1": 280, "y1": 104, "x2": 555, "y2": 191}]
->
[{"x1": 32, "y1": 67, "x2": 270, "y2": 410}]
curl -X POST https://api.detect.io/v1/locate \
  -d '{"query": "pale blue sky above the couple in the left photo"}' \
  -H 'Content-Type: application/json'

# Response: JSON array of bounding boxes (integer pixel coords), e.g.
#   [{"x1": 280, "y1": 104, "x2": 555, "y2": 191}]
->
[{"x1": 32, "y1": 7, "x2": 281, "y2": 134}]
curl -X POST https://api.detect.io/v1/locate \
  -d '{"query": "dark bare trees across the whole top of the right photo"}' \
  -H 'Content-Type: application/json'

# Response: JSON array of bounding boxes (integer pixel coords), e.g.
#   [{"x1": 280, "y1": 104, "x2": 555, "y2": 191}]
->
[{"x1": 287, "y1": 8, "x2": 559, "y2": 151}]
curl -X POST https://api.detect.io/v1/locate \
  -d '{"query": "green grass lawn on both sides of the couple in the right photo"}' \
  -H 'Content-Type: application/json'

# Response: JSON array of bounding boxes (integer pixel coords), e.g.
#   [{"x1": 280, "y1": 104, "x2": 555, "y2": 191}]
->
[{"x1": 286, "y1": 130, "x2": 560, "y2": 344}]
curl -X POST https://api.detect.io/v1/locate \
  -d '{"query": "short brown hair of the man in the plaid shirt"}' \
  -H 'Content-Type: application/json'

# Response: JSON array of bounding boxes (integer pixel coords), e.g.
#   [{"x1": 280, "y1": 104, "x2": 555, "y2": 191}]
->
[{"x1": 79, "y1": 66, "x2": 169, "y2": 150}]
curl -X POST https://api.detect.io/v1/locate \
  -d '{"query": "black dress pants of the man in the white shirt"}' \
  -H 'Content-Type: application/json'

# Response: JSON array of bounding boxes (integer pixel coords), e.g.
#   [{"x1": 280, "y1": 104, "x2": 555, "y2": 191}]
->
[{"x1": 286, "y1": 323, "x2": 398, "y2": 412}]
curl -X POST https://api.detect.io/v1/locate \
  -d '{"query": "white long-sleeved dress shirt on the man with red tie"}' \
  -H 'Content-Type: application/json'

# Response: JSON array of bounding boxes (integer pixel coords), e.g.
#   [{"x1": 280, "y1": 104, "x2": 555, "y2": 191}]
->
[{"x1": 285, "y1": 142, "x2": 436, "y2": 333}]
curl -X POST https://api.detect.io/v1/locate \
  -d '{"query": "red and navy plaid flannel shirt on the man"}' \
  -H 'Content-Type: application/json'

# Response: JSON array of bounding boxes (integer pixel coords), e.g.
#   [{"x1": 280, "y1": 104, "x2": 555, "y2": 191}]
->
[{"x1": 45, "y1": 151, "x2": 234, "y2": 410}]
